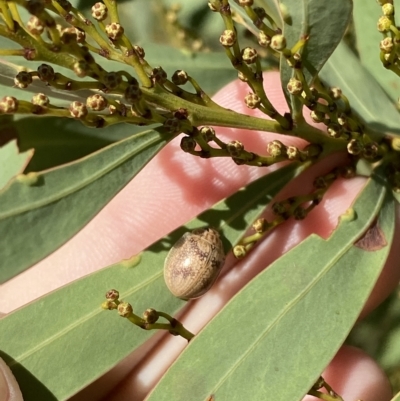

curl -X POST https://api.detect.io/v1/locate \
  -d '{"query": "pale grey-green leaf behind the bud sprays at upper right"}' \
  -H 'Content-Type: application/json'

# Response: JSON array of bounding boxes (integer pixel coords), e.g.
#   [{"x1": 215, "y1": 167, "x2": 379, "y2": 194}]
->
[{"x1": 320, "y1": 42, "x2": 400, "y2": 135}]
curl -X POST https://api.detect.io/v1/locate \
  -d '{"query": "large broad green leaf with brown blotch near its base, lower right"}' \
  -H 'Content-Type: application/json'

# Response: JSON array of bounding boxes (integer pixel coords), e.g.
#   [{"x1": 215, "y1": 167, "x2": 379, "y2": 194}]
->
[{"x1": 147, "y1": 170, "x2": 394, "y2": 401}]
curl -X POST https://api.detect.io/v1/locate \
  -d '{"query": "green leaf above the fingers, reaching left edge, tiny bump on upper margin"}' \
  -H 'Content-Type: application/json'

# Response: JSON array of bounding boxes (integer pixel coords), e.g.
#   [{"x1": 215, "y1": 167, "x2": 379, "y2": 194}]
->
[{"x1": 0, "y1": 130, "x2": 170, "y2": 282}]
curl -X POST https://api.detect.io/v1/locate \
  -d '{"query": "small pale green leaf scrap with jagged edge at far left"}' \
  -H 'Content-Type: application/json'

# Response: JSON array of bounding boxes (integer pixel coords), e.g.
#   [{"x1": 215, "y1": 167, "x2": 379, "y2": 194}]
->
[{"x1": 0, "y1": 140, "x2": 33, "y2": 190}]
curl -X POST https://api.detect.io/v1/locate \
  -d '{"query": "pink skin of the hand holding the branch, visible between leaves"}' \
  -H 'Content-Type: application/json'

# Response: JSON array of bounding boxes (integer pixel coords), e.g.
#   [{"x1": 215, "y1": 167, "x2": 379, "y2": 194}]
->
[{"x1": 0, "y1": 73, "x2": 400, "y2": 401}]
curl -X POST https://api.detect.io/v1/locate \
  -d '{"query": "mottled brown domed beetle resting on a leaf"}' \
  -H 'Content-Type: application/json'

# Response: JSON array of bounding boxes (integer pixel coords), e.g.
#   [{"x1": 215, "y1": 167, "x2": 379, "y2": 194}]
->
[{"x1": 164, "y1": 228, "x2": 225, "y2": 299}]
